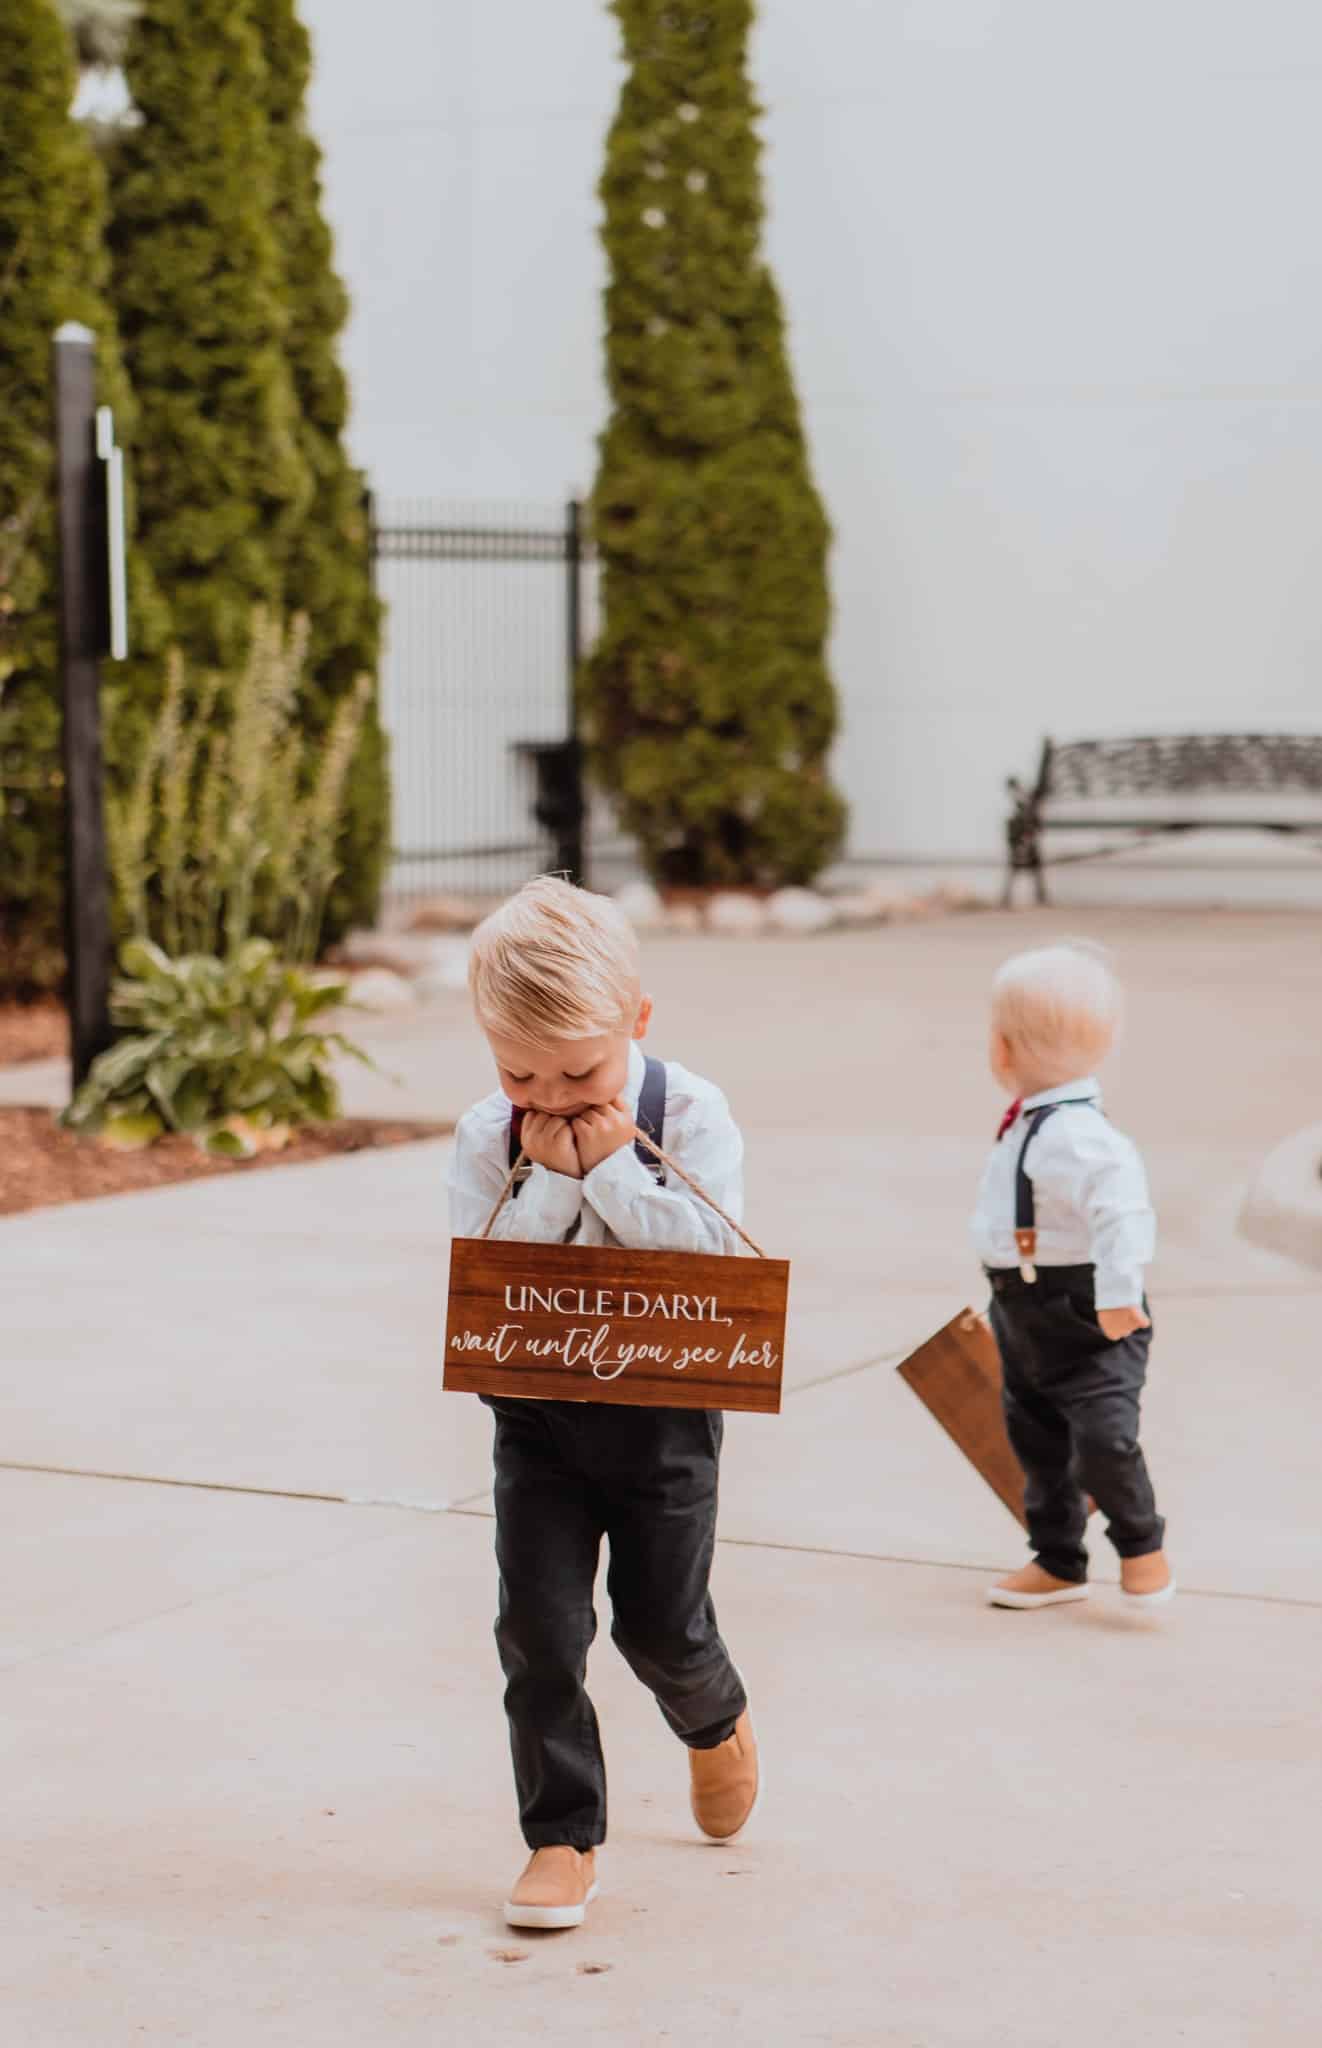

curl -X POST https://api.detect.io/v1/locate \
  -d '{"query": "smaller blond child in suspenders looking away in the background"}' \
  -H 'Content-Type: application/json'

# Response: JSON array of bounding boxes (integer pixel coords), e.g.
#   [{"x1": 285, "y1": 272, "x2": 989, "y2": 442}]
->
[{"x1": 972, "y1": 944, "x2": 1175, "y2": 1608}]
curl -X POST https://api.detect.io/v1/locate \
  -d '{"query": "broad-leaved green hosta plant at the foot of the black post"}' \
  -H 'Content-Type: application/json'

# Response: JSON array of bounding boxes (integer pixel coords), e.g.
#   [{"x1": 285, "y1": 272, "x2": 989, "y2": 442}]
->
[{"x1": 63, "y1": 938, "x2": 366, "y2": 1159}]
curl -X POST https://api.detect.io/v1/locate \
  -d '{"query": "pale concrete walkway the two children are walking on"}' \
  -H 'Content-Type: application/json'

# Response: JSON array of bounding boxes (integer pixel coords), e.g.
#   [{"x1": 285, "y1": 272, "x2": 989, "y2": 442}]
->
[{"x1": 0, "y1": 911, "x2": 1322, "y2": 2048}]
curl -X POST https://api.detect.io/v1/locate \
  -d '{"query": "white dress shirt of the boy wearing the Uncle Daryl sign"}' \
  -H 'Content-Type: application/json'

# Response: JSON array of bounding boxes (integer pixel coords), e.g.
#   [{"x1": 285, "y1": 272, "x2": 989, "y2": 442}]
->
[{"x1": 450, "y1": 1044, "x2": 745, "y2": 1255}]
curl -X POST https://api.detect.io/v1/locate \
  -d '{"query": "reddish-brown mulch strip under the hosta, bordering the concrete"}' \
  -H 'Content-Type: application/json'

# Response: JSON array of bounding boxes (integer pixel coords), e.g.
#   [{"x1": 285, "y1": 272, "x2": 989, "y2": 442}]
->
[{"x1": 0, "y1": 1108, "x2": 454, "y2": 1217}]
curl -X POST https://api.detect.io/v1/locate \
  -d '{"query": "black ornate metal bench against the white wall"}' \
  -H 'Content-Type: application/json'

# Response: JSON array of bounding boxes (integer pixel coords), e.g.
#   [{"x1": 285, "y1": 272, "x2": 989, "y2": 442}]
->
[{"x1": 1005, "y1": 733, "x2": 1322, "y2": 905}]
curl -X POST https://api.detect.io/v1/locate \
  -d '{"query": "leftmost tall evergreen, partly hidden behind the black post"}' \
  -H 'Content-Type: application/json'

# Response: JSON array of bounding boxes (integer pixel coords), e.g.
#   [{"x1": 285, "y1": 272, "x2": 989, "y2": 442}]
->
[{"x1": 0, "y1": 0, "x2": 153, "y2": 991}]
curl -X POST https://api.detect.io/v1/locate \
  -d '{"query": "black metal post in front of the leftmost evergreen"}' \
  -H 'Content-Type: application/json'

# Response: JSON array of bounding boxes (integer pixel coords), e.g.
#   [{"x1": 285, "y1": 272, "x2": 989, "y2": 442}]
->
[{"x1": 55, "y1": 322, "x2": 113, "y2": 1087}]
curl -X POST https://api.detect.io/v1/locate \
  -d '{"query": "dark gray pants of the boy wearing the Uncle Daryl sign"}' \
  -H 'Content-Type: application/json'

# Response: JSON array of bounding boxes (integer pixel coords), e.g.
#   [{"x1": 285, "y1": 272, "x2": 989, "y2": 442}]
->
[{"x1": 487, "y1": 1401, "x2": 747, "y2": 1849}]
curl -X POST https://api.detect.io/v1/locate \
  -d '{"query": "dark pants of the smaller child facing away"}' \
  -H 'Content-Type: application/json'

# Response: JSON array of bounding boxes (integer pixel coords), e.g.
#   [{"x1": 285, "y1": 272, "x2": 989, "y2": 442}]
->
[{"x1": 990, "y1": 1266, "x2": 1166, "y2": 1585}]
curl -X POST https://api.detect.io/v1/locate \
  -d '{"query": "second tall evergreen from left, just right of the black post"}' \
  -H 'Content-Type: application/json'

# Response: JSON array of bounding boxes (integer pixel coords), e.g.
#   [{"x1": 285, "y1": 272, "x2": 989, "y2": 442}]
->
[{"x1": 111, "y1": 0, "x2": 313, "y2": 668}]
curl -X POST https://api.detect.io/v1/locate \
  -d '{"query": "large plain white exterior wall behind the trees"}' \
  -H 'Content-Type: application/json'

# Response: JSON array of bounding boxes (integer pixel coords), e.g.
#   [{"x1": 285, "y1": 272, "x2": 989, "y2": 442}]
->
[{"x1": 303, "y1": 0, "x2": 1322, "y2": 860}]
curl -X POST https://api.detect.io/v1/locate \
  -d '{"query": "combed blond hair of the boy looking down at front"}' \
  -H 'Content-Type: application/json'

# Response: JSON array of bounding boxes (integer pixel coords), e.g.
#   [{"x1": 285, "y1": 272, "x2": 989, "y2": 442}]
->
[{"x1": 469, "y1": 874, "x2": 641, "y2": 1047}]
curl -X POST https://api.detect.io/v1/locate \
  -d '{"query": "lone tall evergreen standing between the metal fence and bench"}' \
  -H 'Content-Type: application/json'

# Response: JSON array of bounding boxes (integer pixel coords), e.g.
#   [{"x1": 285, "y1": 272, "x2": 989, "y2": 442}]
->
[{"x1": 583, "y1": 0, "x2": 845, "y2": 885}]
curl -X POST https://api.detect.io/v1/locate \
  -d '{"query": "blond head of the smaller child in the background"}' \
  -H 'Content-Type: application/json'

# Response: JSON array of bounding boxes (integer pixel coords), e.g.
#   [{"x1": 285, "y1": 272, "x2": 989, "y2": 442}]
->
[{"x1": 993, "y1": 938, "x2": 1123, "y2": 1085}]
